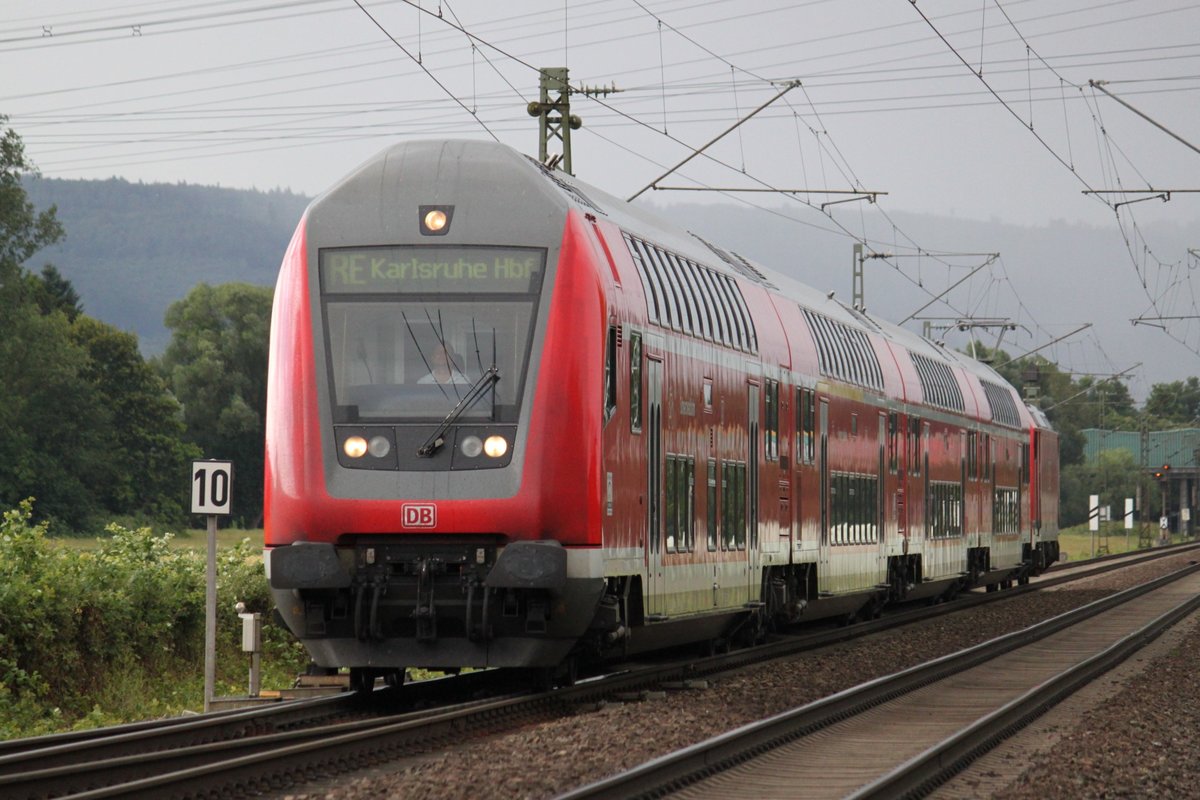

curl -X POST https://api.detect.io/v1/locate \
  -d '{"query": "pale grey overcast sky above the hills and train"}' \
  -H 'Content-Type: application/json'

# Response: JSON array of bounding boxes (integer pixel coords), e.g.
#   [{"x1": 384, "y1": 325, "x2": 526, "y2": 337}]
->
[{"x1": 0, "y1": 0, "x2": 1200, "y2": 398}]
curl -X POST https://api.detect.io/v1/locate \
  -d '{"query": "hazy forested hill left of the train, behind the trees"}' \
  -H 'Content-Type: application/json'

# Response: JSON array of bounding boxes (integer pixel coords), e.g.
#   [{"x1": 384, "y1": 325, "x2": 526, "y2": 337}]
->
[{"x1": 24, "y1": 178, "x2": 308, "y2": 355}]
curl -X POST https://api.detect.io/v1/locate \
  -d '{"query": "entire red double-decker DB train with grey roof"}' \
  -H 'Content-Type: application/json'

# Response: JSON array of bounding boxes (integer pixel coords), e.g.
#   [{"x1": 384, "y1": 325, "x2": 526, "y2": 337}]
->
[{"x1": 265, "y1": 142, "x2": 1058, "y2": 685}]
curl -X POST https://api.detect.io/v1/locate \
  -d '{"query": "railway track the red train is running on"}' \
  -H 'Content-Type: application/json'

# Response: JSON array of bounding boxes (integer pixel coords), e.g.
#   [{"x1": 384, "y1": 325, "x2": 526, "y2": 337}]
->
[{"x1": 0, "y1": 549, "x2": 1178, "y2": 798}]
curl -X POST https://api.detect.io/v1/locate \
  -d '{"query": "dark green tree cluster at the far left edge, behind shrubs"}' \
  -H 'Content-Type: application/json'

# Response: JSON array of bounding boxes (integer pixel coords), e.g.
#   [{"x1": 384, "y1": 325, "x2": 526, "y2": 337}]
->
[{"x1": 0, "y1": 118, "x2": 194, "y2": 531}]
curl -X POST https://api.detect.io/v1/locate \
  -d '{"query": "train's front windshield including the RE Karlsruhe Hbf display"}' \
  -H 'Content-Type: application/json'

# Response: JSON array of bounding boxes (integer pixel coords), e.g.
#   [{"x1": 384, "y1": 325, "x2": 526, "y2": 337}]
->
[{"x1": 320, "y1": 246, "x2": 546, "y2": 422}]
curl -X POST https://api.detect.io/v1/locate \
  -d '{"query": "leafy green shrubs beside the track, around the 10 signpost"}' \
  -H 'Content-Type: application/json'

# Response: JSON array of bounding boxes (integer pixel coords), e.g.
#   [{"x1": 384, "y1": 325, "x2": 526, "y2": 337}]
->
[{"x1": 0, "y1": 500, "x2": 306, "y2": 738}]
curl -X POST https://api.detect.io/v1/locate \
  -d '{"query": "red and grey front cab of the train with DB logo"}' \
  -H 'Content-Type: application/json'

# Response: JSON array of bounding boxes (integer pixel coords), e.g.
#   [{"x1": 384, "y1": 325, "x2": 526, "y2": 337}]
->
[{"x1": 266, "y1": 146, "x2": 619, "y2": 678}]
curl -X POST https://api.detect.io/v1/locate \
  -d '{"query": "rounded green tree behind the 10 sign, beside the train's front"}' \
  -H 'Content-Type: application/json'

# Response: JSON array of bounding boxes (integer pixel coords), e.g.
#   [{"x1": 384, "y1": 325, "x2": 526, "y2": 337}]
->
[{"x1": 160, "y1": 283, "x2": 271, "y2": 523}]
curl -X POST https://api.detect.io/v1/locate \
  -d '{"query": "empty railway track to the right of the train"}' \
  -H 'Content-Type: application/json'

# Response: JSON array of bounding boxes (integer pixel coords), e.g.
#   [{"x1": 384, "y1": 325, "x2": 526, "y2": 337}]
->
[{"x1": 559, "y1": 564, "x2": 1200, "y2": 800}]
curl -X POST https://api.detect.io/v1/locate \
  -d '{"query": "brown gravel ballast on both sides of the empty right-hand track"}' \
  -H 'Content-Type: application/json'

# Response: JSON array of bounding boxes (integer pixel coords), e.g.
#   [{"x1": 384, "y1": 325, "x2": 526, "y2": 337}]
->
[{"x1": 282, "y1": 555, "x2": 1200, "y2": 800}]
